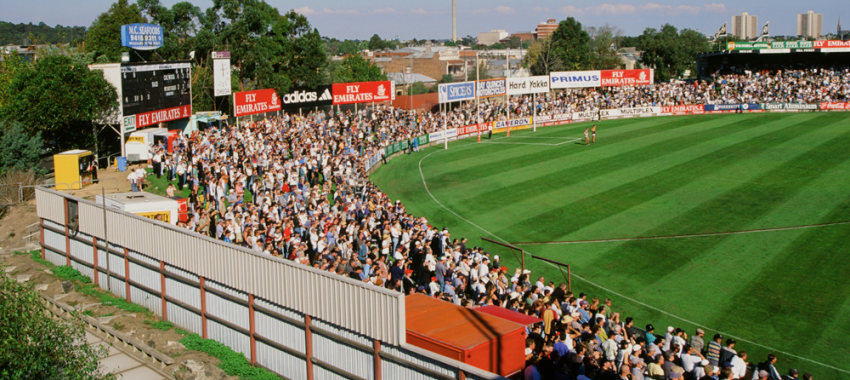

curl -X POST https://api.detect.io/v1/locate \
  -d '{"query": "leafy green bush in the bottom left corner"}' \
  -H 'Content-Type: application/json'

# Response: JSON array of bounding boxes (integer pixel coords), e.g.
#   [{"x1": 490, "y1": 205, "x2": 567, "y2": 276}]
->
[{"x1": 0, "y1": 266, "x2": 115, "y2": 380}]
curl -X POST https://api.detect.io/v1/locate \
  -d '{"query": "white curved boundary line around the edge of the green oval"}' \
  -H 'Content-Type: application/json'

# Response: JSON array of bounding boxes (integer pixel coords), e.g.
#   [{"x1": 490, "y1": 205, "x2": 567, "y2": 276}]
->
[{"x1": 419, "y1": 144, "x2": 850, "y2": 374}]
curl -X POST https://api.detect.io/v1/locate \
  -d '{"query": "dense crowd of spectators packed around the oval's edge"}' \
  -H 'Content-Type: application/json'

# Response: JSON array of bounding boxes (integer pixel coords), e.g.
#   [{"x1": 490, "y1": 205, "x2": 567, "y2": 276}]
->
[{"x1": 131, "y1": 68, "x2": 850, "y2": 380}]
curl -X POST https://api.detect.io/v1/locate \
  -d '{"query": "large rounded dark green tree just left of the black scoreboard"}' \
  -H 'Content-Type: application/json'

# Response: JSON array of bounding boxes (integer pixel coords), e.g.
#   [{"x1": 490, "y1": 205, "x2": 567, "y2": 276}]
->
[{"x1": 0, "y1": 55, "x2": 118, "y2": 151}]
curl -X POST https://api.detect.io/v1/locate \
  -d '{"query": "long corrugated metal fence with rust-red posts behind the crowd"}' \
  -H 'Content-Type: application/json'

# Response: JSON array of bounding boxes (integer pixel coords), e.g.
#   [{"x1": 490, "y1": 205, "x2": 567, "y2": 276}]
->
[{"x1": 36, "y1": 188, "x2": 500, "y2": 380}]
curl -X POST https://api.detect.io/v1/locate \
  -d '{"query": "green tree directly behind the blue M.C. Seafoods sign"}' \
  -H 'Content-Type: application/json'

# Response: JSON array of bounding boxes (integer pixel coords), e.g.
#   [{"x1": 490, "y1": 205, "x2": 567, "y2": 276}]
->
[{"x1": 86, "y1": 0, "x2": 146, "y2": 62}]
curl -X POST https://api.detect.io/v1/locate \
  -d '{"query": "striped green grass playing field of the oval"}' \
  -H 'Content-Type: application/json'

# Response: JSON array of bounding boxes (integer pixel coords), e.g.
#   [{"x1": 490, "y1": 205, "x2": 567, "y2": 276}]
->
[{"x1": 372, "y1": 113, "x2": 850, "y2": 379}]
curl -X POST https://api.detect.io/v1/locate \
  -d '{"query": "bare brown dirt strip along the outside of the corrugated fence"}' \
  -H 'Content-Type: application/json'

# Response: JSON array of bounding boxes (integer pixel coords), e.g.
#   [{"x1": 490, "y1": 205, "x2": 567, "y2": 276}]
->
[{"x1": 0, "y1": 200, "x2": 236, "y2": 380}]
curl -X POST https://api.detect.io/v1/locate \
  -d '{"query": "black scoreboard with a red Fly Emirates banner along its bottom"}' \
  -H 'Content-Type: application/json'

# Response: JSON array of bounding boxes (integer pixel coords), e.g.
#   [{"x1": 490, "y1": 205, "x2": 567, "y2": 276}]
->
[{"x1": 121, "y1": 61, "x2": 192, "y2": 128}]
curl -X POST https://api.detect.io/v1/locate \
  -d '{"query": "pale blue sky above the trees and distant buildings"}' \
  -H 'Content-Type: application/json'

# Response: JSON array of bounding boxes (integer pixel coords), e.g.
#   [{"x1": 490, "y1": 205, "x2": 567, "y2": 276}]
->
[{"x1": 6, "y1": 0, "x2": 850, "y2": 39}]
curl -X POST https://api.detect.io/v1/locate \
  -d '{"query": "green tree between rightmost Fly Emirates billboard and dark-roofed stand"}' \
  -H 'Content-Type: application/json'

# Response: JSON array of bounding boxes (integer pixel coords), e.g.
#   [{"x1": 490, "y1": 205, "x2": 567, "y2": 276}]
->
[{"x1": 637, "y1": 24, "x2": 709, "y2": 82}]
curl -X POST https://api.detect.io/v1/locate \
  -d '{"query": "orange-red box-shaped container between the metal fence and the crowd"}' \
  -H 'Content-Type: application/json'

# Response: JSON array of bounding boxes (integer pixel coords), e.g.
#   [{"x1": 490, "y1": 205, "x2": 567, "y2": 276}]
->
[{"x1": 404, "y1": 294, "x2": 526, "y2": 377}]
